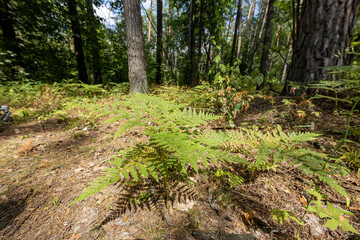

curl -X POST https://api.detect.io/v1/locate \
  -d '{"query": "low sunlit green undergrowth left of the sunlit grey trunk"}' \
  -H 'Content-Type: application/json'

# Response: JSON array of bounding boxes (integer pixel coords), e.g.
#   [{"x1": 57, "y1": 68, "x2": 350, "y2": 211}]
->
[{"x1": 0, "y1": 80, "x2": 128, "y2": 122}]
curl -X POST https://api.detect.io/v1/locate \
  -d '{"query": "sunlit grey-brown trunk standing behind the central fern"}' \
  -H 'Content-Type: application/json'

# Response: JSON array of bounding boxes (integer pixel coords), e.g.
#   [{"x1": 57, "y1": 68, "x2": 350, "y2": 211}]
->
[{"x1": 124, "y1": 0, "x2": 148, "y2": 93}]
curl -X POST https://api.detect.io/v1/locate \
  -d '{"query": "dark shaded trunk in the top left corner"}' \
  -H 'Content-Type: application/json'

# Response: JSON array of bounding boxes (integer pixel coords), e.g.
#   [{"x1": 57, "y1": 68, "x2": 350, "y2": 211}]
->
[{"x1": 0, "y1": 0, "x2": 21, "y2": 64}]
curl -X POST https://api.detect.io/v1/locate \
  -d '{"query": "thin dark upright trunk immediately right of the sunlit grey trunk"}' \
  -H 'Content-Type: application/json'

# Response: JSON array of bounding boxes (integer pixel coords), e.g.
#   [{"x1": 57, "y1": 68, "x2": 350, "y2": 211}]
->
[{"x1": 156, "y1": 0, "x2": 163, "y2": 84}]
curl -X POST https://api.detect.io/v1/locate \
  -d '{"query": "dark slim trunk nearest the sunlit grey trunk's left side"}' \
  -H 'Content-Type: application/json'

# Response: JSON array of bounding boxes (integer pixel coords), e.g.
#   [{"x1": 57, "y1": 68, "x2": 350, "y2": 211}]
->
[{"x1": 86, "y1": 0, "x2": 103, "y2": 84}]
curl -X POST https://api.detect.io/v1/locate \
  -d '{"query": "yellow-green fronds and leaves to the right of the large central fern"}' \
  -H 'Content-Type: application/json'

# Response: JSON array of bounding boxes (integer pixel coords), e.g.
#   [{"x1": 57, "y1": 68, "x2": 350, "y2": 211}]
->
[{"x1": 224, "y1": 127, "x2": 356, "y2": 236}]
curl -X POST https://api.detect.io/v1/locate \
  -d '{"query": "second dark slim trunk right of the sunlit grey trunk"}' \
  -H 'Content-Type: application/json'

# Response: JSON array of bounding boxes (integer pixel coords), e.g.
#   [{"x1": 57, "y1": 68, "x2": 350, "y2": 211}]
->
[{"x1": 187, "y1": 0, "x2": 196, "y2": 87}]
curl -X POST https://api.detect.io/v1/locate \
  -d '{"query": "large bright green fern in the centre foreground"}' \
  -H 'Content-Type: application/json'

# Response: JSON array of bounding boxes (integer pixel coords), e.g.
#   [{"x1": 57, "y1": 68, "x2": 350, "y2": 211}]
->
[{"x1": 72, "y1": 93, "x2": 241, "y2": 204}]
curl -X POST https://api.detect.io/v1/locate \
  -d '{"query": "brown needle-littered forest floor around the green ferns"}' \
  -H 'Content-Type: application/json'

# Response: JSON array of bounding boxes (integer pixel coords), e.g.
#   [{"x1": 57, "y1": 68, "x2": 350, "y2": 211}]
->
[{"x1": 0, "y1": 93, "x2": 360, "y2": 240}]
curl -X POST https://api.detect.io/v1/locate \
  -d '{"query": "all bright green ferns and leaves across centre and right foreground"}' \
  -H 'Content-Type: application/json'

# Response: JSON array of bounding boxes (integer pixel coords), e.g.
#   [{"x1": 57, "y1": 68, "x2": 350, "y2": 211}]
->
[{"x1": 71, "y1": 94, "x2": 358, "y2": 237}]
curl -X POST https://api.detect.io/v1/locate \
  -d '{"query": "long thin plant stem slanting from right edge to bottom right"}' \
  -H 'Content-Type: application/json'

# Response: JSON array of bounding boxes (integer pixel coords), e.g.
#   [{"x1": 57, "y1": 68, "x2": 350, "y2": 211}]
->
[{"x1": 295, "y1": 95, "x2": 360, "y2": 239}]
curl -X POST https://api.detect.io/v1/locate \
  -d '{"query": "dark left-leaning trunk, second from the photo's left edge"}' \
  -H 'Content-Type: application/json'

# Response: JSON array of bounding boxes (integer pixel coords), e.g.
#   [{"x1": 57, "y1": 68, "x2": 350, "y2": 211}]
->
[{"x1": 68, "y1": 0, "x2": 89, "y2": 84}]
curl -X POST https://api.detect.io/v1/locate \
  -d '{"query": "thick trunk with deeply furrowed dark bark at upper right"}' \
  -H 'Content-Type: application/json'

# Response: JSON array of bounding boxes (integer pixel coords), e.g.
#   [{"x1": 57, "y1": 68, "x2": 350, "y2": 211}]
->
[{"x1": 283, "y1": 0, "x2": 360, "y2": 94}]
